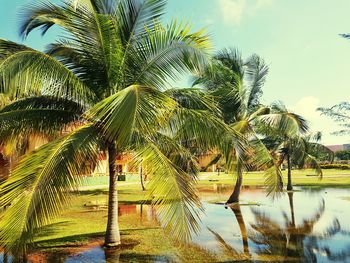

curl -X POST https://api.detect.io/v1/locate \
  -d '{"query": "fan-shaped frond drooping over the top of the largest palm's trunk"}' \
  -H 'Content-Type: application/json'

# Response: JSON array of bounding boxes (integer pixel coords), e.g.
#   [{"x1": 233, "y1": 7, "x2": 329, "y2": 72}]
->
[{"x1": 86, "y1": 85, "x2": 176, "y2": 147}]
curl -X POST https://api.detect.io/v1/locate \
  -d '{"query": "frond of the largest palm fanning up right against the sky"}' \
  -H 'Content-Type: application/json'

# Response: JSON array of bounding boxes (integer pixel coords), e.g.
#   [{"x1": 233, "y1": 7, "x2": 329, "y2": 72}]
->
[{"x1": 128, "y1": 20, "x2": 210, "y2": 89}]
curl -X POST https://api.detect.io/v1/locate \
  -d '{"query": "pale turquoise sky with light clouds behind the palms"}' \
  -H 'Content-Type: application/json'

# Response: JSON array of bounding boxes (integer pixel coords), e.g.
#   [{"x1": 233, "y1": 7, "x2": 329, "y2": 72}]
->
[{"x1": 0, "y1": 0, "x2": 350, "y2": 144}]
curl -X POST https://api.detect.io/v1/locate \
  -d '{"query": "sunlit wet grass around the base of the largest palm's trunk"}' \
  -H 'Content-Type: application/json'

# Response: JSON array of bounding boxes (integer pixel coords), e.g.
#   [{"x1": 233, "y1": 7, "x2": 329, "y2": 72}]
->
[{"x1": 29, "y1": 185, "x2": 230, "y2": 262}]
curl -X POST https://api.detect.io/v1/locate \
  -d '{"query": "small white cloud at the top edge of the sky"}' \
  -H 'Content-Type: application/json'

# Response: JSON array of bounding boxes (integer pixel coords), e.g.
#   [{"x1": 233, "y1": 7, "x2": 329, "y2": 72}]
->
[{"x1": 218, "y1": 0, "x2": 273, "y2": 25}]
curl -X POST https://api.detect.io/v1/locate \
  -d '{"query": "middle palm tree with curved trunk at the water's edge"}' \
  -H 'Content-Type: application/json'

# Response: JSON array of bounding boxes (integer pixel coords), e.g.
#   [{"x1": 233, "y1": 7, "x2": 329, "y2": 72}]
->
[{"x1": 193, "y1": 49, "x2": 297, "y2": 203}]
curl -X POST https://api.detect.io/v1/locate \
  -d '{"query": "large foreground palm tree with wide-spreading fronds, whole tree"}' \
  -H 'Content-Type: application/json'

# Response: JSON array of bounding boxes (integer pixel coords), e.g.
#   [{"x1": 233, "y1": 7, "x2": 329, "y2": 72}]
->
[{"x1": 0, "y1": 0, "x2": 235, "y2": 256}]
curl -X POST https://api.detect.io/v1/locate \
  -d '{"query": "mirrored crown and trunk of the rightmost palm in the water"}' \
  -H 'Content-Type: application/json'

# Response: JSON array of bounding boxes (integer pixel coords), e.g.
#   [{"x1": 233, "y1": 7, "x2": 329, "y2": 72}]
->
[{"x1": 249, "y1": 192, "x2": 340, "y2": 262}]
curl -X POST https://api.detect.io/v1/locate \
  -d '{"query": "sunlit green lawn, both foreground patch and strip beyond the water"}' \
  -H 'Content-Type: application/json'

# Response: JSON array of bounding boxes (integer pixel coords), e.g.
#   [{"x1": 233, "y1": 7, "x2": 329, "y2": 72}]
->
[{"x1": 23, "y1": 170, "x2": 350, "y2": 262}]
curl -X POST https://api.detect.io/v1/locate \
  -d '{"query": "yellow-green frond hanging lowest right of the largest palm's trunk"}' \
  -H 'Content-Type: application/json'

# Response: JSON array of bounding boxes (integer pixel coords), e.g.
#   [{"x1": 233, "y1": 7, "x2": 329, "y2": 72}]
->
[{"x1": 136, "y1": 141, "x2": 201, "y2": 241}]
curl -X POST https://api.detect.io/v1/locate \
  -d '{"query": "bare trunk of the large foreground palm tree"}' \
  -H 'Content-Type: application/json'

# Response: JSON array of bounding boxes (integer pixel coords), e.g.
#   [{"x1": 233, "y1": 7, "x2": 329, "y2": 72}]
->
[{"x1": 105, "y1": 143, "x2": 120, "y2": 247}]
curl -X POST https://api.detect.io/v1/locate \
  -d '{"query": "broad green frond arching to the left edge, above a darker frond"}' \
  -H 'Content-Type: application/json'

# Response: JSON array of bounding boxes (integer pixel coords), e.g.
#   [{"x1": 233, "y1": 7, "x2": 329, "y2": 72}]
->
[{"x1": 0, "y1": 40, "x2": 95, "y2": 103}]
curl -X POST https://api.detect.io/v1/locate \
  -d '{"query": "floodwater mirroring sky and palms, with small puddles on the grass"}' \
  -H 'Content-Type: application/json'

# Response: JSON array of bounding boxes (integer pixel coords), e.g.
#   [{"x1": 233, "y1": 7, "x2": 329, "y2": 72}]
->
[{"x1": 2, "y1": 185, "x2": 350, "y2": 263}]
